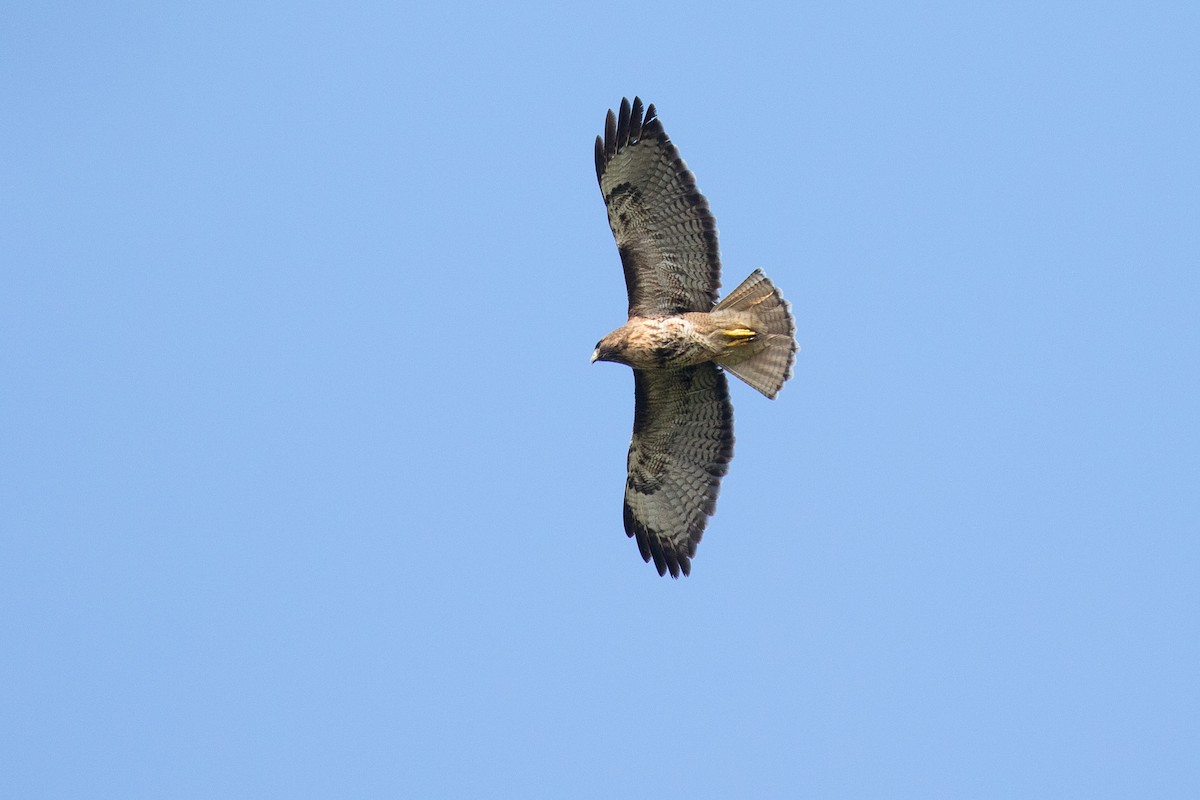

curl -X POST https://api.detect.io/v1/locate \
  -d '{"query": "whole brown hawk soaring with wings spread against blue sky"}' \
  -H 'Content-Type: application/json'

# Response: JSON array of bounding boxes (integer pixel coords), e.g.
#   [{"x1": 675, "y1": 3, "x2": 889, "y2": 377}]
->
[{"x1": 592, "y1": 97, "x2": 797, "y2": 578}]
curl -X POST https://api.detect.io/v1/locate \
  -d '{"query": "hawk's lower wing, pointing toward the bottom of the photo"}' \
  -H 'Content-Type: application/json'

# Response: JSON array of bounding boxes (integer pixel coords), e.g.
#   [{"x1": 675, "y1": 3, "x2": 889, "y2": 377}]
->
[{"x1": 625, "y1": 362, "x2": 733, "y2": 578}]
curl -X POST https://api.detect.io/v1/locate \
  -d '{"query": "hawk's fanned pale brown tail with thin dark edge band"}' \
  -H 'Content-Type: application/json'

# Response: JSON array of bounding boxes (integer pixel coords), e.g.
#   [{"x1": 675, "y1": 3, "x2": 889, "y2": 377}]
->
[{"x1": 713, "y1": 270, "x2": 799, "y2": 399}]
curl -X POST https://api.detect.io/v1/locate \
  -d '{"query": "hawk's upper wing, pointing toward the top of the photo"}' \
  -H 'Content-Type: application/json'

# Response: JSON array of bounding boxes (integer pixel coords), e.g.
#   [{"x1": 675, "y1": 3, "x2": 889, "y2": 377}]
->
[{"x1": 596, "y1": 97, "x2": 721, "y2": 317}]
